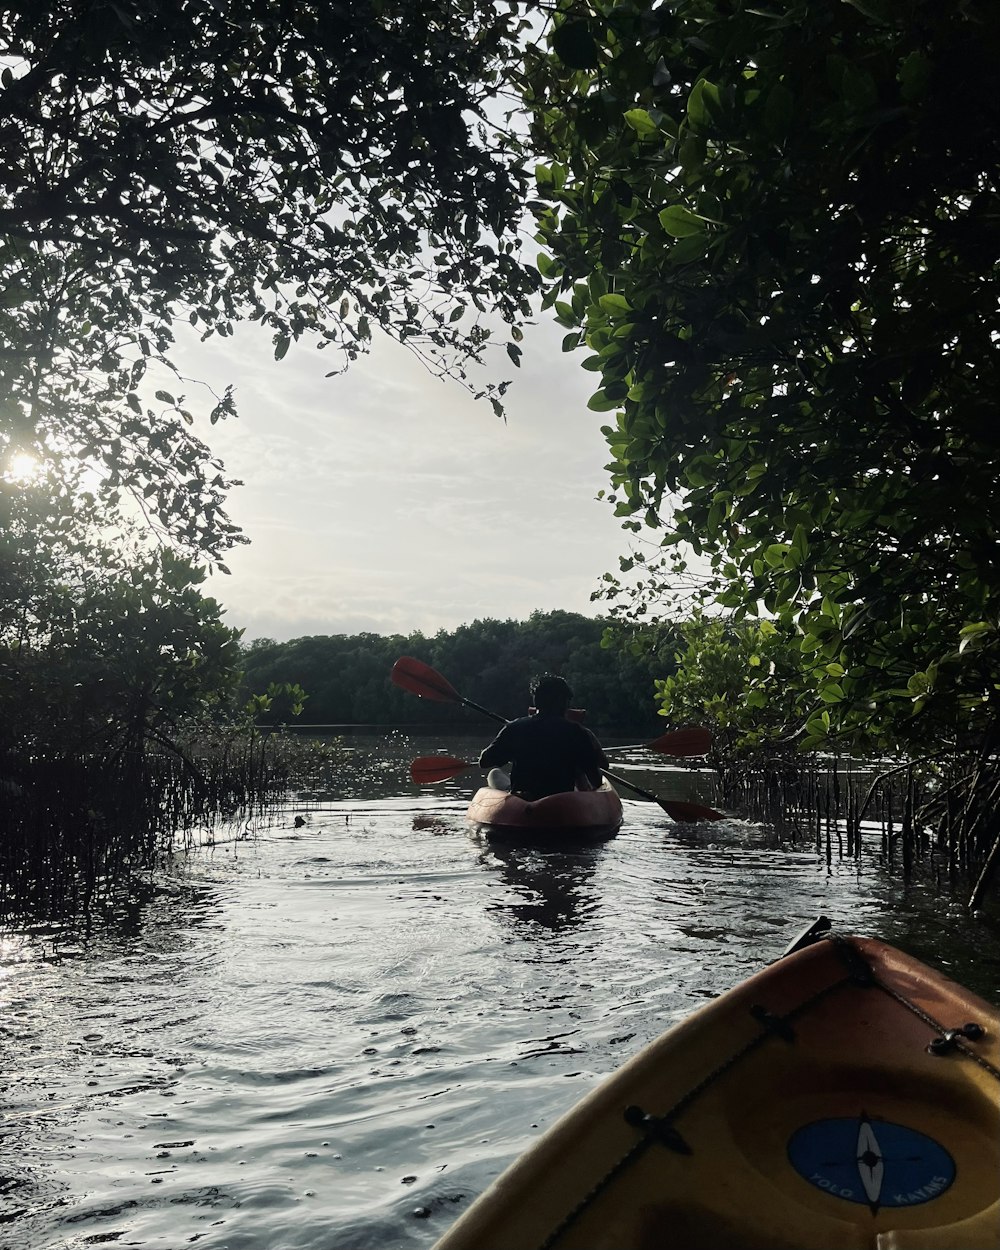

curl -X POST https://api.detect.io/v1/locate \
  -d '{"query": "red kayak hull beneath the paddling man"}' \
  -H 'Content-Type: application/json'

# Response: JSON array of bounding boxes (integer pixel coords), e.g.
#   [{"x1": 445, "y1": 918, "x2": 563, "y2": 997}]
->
[{"x1": 468, "y1": 781, "x2": 623, "y2": 843}]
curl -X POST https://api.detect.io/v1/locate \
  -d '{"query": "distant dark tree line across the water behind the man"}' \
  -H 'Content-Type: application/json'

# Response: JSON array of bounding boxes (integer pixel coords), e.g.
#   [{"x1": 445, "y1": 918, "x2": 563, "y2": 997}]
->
[{"x1": 243, "y1": 611, "x2": 679, "y2": 730}]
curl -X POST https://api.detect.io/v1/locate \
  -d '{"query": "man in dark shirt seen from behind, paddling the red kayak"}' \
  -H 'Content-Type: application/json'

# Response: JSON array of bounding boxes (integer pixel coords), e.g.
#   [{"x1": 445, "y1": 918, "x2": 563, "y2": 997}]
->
[{"x1": 479, "y1": 676, "x2": 608, "y2": 799}]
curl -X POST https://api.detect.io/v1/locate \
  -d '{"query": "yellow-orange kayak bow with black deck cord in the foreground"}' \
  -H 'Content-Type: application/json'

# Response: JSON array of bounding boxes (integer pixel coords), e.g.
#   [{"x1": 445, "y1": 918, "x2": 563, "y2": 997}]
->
[{"x1": 435, "y1": 934, "x2": 1000, "y2": 1250}]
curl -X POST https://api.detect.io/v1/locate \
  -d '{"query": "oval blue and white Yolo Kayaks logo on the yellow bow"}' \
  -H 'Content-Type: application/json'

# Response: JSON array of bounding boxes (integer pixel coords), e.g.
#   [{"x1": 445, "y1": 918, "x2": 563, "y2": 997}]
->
[{"x1": 789, "y1": 1114, "x2": 955, "y2": 1214}]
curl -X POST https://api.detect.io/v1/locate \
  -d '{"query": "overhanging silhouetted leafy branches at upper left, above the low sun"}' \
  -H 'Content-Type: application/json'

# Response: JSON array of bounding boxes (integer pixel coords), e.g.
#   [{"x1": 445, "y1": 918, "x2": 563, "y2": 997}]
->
[{"x1": 0, "y1": 0, "x2": 538, "y2": 563}]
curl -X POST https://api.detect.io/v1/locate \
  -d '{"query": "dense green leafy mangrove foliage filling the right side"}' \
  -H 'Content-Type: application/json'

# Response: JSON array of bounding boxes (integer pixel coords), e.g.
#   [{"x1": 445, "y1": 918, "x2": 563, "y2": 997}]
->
[{"x1": 524, "y1": 0, "x2": 1000, "y2": 900}]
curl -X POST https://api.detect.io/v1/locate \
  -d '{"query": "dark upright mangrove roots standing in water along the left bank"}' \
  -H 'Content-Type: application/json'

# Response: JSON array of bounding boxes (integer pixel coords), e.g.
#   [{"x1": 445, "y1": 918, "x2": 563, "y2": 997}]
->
[{"x1": 0, "y1": 726, "x2": 344, "y2": 926}]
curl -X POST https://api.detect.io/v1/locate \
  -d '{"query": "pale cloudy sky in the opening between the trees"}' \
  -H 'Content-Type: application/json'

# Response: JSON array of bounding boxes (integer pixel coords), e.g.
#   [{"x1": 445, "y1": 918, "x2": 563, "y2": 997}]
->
[{"x1": 175, "y1": 314, "x2": 630, "y2": 641}]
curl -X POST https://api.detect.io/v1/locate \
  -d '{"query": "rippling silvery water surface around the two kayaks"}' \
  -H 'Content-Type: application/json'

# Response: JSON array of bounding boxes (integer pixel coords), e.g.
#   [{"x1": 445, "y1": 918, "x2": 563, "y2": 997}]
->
[{"x1": 0, "y1": 739, "x2": 1000, "y2": 1250}]
